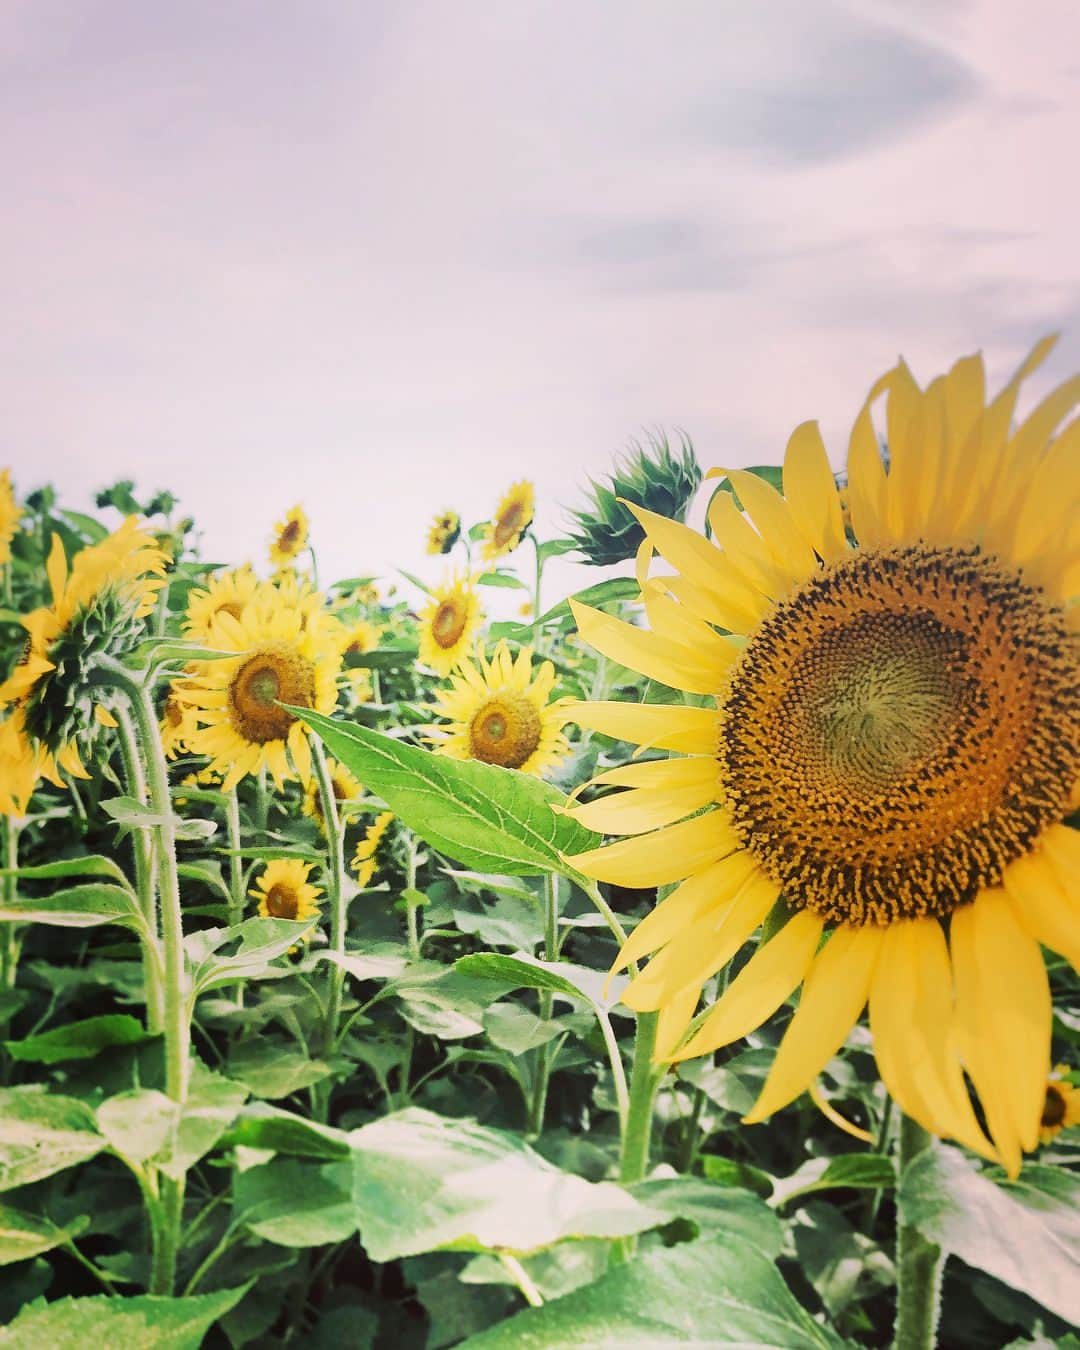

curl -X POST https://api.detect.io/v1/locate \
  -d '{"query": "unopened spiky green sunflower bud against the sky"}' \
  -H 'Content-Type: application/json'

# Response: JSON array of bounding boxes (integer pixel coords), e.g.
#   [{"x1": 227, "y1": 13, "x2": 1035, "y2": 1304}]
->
[{"x1": 568, "y1": 436, "x2": 701, "y2": 567}]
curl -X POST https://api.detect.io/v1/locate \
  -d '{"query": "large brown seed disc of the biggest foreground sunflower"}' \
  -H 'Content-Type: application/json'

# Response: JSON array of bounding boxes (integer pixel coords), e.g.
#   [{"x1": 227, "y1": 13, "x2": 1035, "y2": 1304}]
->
[{"x1": 718, "y1": 545, "x2": 1080, "y2": 923}]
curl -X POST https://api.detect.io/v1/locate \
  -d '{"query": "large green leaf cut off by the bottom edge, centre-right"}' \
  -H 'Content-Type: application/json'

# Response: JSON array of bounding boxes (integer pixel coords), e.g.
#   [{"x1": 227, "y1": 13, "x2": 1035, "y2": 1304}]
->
[{"x1": 462, "y1": 1233, "x2": 841, "y2": 1350}]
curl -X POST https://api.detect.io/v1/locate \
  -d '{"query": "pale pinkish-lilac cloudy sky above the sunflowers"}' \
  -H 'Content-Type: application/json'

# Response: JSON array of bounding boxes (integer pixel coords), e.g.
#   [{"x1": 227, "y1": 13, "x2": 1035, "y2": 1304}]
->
[{"x1": 0, "y1": 0, "x2": 1080, "y2": 602}]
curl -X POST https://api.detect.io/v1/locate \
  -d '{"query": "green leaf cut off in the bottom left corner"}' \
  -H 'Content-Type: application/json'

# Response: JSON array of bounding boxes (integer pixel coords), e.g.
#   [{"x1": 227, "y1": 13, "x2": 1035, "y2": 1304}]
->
[{"x1": 0, "y1": 1285, "x2": 248, "y2": 1350}]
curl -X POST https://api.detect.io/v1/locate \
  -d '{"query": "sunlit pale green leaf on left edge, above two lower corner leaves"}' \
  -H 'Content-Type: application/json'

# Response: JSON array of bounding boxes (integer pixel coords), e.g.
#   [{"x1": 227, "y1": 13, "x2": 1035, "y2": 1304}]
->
[{"x1": 0, "y1": 1088, "x2": 105, "y2": 1188}]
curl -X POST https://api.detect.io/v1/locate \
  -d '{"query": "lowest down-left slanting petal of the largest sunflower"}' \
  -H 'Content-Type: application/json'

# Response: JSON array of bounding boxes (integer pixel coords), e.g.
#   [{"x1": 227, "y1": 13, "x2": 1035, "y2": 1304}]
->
[{"x1": 744, "y1": 925, "x2": 884, "y2": 1125}]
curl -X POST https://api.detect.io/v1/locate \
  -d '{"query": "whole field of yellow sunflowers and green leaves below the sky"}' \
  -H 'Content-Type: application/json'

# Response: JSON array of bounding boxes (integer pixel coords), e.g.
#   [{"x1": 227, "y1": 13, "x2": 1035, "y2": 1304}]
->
[{"x1": 0, "y1": 343, "x2": 1080, "y2": 1350}]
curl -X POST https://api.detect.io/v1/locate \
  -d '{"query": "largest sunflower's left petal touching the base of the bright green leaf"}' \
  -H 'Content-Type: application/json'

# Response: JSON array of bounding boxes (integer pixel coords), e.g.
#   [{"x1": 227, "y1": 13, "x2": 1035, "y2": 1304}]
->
[{"x1": 567, "y1": 810, "x2": 740, "y2": 888}]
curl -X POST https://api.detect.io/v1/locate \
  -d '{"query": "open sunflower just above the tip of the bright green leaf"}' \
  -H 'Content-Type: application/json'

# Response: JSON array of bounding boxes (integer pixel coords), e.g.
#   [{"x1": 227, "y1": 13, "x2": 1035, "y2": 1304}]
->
[{"x1": 186, "y1": 605, "x2": 342, "y2": 791}]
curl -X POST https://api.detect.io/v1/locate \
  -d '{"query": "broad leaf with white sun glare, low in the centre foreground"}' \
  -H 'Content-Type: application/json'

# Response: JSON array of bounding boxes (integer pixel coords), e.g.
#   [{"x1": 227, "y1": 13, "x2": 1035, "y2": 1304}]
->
[{"x1": 350, "y1": 1107, "x2": 663, "y2": 1261}]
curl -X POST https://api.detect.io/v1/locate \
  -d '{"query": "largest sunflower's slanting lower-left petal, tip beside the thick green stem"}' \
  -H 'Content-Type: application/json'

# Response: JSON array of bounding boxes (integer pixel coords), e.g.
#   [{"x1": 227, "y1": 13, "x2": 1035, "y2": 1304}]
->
[{"x1": 675, "y1": 910, "x2": 825, "y2": 1060}]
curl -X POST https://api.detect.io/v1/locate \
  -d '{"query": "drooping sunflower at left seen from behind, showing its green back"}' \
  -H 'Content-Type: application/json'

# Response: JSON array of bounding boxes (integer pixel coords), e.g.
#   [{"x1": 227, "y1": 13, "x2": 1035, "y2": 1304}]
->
[{"x1": 0, "y1": 517, "x2": 166, "y2": 786}]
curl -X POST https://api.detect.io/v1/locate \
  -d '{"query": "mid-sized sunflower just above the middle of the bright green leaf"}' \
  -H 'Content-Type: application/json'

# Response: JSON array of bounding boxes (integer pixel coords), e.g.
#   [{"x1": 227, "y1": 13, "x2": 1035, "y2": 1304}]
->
[{"x1": 428, "y1": 643, "x2": 570, "y2": 778}]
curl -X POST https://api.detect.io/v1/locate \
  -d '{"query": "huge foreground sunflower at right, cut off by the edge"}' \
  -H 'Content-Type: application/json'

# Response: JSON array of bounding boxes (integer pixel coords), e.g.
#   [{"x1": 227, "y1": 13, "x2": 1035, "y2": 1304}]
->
[{"x1": 572, "y1": 343, "x2": 1080, "y2": 1175}]
